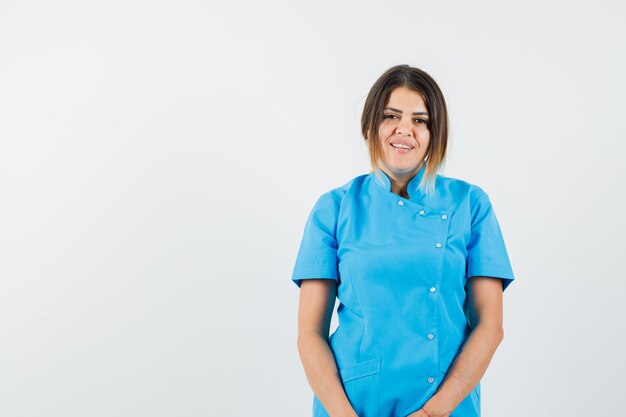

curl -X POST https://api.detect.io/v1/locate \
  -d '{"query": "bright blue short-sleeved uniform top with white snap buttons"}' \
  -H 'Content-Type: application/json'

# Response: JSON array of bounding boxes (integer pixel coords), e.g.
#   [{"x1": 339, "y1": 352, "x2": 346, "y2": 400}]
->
[{"x1": 291, "y1": 165, "x2": 514, "y2": 417}]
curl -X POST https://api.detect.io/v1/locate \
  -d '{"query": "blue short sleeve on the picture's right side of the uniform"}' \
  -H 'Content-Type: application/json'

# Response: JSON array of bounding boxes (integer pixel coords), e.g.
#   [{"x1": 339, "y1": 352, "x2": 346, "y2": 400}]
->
[{"x1": 466, "y1": 188, "x2": 515, "y2": 291}]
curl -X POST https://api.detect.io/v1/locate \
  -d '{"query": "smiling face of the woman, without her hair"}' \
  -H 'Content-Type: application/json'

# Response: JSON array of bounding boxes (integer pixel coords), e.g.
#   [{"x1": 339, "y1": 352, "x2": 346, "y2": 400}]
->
[{"x1": 379, "y1": 87, "x2": 430, "y2": 178}]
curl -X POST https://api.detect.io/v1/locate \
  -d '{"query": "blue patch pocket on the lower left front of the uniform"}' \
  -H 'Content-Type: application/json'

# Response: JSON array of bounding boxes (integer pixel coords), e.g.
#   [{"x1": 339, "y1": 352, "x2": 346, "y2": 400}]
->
[{"x1": 339, "y1": 358, "x2": 380, "y2": 417}]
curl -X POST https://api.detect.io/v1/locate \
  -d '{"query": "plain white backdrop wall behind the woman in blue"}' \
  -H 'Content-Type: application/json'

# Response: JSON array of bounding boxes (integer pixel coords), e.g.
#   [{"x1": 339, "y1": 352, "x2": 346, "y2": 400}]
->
[{"x1": 0, "y1": 0, "x2": 626, "y2": 417}]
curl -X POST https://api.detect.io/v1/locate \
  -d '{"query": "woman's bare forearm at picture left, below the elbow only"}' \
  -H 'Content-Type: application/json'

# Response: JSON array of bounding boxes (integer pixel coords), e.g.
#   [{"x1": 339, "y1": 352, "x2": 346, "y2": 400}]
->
[{"x1": 298, "y1": 332, "x2": 357, "y2": 417}]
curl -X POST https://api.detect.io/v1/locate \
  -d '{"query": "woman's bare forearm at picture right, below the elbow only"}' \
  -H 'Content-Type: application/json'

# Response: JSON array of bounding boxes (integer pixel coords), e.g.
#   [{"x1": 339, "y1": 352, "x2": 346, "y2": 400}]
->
[{"x1": 424, "y1": 324, "x2": 503, "y2": 415}]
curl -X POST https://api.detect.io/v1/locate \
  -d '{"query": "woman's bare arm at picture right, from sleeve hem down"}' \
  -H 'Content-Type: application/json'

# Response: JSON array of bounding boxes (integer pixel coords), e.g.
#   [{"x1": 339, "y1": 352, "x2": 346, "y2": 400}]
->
[{"x1": 417, "y1": 276, "x2": 504, "y2": 417}]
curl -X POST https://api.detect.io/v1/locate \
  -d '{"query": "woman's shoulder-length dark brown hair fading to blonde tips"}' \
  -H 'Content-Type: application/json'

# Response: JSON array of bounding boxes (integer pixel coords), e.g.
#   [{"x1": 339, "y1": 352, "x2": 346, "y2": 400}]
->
[{"x1": 361, "y1": 65, "x2": 448, "y2": 194}]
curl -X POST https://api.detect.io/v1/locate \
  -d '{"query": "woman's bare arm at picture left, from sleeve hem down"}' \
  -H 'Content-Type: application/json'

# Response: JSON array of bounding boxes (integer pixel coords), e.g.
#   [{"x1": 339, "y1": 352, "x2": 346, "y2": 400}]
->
[{"x1": 298, "y1": 279, "x2": 358, "y2": 417}]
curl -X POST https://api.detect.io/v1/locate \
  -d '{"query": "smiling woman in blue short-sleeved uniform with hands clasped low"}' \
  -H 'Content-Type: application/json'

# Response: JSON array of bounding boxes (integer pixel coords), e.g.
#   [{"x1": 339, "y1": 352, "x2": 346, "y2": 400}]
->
[{"x1": 292, "y1": 65, "x2": 514, "y2": 417}]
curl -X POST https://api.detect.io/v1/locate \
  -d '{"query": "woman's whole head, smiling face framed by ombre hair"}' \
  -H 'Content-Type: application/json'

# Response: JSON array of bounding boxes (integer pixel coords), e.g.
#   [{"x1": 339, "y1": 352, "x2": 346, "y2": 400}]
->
[{"x1": 361, "y1": 65, "x2": 448, "y2": 195}]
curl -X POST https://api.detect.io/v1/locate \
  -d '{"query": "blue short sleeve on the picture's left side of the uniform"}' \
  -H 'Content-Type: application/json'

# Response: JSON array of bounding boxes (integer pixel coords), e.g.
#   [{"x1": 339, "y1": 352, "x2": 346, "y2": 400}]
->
[{"x1": 291, "y1": 192, "x2": 339, "y2": 288}]
